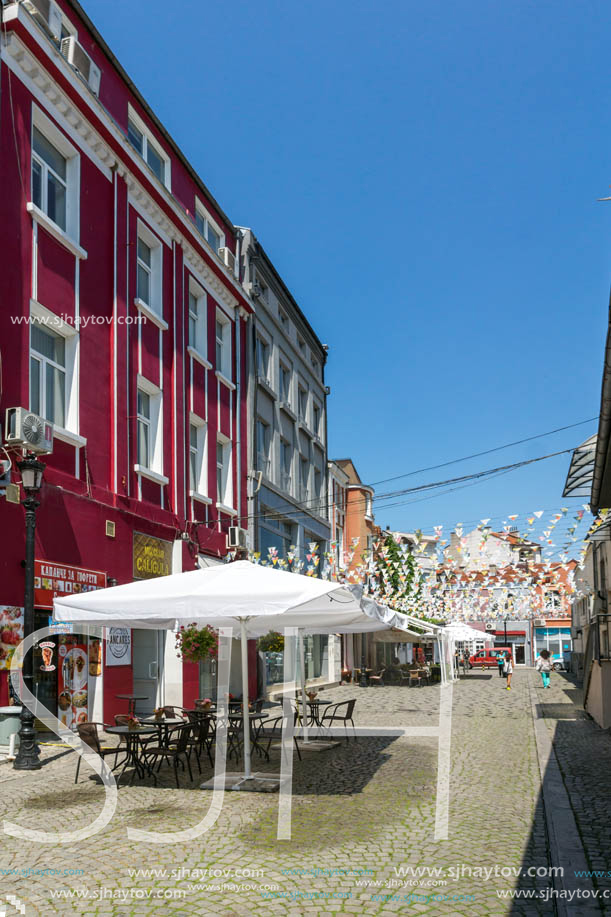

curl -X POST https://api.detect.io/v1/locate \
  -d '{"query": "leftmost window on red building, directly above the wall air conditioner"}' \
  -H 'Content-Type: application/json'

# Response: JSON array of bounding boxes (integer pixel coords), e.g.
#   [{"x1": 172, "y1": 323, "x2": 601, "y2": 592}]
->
[{"x1": 30, "y1": 323, "x2": 66, "y2": 427}]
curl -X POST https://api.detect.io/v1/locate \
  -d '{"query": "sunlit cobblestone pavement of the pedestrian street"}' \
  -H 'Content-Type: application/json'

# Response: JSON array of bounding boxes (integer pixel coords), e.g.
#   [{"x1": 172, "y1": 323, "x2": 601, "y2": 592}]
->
[{"x1": 0, "y1": 669, "x2": 611, "y2": 917}]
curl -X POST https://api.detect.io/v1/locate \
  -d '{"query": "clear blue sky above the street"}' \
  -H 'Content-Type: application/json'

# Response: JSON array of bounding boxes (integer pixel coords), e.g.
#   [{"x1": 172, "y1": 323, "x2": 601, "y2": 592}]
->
[{"x1": 84, "y1": 0, "x2": 611, "y2": 530}]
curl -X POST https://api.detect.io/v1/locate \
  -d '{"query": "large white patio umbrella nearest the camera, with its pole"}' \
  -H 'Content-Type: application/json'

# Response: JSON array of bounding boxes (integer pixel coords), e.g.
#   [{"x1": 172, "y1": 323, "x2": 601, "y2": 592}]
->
[{"x1": 53, "y1": 560, "x2": 406, "y2": 780}]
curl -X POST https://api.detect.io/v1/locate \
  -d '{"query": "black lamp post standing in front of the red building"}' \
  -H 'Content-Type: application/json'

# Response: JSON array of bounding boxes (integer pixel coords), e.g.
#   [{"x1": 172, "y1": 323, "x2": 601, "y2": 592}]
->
[{"x1": 13, "y1": 453, "x2": 45, "y2": 771}]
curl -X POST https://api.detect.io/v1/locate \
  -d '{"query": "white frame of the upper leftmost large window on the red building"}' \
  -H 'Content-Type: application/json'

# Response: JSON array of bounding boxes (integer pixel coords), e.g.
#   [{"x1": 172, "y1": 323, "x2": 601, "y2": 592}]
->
[{"x1": 27, "y1": 105, "x2": 80, "y2": 243}]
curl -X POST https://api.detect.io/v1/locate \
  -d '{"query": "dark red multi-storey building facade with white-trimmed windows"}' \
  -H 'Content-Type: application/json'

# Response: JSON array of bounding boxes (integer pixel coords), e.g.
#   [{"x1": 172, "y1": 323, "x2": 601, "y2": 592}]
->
[{"x1": 0, "y1": 0, "x2": 252, "y2": 721}]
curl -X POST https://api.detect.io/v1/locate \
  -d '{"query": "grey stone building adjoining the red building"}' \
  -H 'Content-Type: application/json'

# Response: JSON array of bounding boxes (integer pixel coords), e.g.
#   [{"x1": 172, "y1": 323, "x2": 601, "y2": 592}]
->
[{"x1": 238, "y1": 227, "x2": 330, "y2": 568}]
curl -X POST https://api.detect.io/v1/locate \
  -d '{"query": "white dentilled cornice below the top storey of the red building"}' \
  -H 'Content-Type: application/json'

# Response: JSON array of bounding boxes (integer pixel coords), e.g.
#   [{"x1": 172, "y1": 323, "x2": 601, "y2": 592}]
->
[{"x1": 2, "y1": 22, "x2": 244, "y2": 309}]
